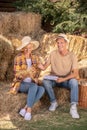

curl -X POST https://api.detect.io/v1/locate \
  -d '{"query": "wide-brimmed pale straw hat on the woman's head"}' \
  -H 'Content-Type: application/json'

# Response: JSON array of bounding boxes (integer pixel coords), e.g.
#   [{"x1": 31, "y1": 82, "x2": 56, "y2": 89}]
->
[{"x1": 17, "y1": 36, "x2": 39, "y2": 50}]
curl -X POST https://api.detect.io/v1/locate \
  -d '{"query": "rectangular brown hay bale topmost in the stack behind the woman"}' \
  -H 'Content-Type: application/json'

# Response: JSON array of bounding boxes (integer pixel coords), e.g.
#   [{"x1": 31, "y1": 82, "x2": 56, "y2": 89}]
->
[{"x1": 0, "y1": 12, "x2": 41, "y2": 35}]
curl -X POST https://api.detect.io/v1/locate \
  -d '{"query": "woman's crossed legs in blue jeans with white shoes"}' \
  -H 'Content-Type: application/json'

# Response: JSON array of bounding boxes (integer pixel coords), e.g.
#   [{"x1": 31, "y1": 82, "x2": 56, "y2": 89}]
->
[{"x1": 19, "y1": 82, "x2": 44, "y2": 120}]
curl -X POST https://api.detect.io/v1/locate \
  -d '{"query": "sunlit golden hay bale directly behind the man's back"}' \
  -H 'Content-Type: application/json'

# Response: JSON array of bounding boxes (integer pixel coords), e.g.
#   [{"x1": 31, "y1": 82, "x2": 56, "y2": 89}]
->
[{"x1": 39, "y1": 33, "x2": 87, "y2": 80}]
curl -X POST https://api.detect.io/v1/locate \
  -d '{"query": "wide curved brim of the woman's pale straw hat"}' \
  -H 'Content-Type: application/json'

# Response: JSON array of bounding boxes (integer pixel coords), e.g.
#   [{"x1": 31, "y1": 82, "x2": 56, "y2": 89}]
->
[{"x1": 16, "y1": 40, "x2": 39, "y2": 51}]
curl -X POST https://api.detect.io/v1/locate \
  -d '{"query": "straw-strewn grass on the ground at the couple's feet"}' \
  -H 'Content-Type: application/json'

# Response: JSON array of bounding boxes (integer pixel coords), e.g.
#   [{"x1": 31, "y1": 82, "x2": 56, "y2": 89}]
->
[{"x1": 0, "y1": 105, "x2": 87, "y2": 130}]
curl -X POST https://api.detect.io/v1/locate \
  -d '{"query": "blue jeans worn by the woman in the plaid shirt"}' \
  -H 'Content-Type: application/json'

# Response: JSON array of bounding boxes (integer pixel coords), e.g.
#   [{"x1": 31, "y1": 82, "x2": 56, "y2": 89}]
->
[{"x1": 19, "y1": 81, "x2": 45, "y2": 108}]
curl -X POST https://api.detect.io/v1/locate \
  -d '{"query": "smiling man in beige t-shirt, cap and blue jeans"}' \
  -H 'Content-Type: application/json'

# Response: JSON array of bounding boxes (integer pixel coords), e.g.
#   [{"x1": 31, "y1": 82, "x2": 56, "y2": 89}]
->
[{"x1": 38, "y1": 34, "x2": 79, "y2": 118}]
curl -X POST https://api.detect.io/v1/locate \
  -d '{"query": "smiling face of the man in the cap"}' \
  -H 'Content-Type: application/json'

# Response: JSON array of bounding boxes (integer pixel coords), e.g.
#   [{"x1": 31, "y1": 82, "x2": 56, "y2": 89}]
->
[{"x1": 57, "y1": 38, "x2": 67, "y2": 51}]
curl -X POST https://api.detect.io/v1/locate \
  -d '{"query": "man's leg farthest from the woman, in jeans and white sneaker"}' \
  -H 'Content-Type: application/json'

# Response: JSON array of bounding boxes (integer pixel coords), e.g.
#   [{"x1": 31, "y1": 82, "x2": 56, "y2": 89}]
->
[{"x1": 58, "y1": 79, "x2": 79, "y2": 118}]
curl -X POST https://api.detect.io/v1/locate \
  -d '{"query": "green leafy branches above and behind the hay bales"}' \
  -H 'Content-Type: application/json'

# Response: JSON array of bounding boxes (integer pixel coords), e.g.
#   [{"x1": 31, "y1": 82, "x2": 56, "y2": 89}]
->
[{"x1": 15, "y1": 0, "x2": 87, "y2": 33}]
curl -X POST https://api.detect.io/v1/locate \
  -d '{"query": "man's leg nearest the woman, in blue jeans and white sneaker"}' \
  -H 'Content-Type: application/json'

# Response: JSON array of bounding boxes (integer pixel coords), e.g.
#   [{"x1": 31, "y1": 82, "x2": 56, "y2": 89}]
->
[{"x1": 43, "y1": 80, "x2": 58, "y2": 111}]
